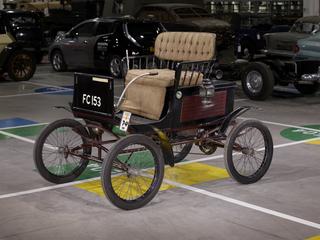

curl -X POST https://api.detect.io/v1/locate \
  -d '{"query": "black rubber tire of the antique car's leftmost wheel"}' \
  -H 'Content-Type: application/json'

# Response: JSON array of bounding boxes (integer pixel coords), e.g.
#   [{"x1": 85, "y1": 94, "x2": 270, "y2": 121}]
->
[{"x1": 33, "y1": 119, "x2": 91, "y2": 184}]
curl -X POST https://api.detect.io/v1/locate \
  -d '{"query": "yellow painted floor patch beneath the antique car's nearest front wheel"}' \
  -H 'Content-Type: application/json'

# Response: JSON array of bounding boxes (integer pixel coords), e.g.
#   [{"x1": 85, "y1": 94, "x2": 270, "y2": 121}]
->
[{"x1": 75, "y1": 163, "x2": 229, "y2": 196}]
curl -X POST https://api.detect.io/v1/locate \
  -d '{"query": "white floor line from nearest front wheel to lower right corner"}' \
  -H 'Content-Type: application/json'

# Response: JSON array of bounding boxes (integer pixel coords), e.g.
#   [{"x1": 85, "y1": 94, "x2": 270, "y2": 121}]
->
[{"x1": 163, "y1": 179, "x2": 320, "y2": 229}]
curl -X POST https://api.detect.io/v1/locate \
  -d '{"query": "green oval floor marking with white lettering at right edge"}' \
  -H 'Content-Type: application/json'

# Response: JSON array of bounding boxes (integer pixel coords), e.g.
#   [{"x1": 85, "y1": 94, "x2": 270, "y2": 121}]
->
[{"x1": 280, "y1": 125, "x2": 320, "y2": 141}]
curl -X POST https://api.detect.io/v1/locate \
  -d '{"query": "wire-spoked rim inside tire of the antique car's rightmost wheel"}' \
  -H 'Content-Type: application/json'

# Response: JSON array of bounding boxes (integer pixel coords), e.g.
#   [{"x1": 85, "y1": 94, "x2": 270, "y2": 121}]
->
[{"x1": 232, "y1": 127, "x2": 267, "y2": 177}]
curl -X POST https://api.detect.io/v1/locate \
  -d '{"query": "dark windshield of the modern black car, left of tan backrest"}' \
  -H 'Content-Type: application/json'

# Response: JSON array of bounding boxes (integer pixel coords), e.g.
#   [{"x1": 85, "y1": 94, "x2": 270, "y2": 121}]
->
[{"x1": 127, "y1": 23, "x2": 162, "y2": 43}]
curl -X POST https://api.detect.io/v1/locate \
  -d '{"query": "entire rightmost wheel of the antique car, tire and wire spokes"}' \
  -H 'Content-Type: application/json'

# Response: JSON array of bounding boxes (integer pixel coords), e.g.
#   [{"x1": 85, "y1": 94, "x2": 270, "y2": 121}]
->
[{"x1": 224, "y1": 120, "x2": 273, "y2": 184}]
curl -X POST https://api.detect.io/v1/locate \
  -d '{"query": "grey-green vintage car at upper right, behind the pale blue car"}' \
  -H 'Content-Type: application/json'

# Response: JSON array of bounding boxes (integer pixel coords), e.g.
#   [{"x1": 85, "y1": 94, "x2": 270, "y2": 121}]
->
[{"x1": 265, "y1": 16, "x2": 320, "y2": 57}]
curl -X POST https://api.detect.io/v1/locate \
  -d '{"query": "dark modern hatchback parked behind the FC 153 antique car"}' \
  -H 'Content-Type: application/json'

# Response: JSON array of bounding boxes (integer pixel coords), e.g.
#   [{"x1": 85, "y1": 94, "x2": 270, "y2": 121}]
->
[{"x1": 49, "y1": 18, "x2": 164, "y2": 77}]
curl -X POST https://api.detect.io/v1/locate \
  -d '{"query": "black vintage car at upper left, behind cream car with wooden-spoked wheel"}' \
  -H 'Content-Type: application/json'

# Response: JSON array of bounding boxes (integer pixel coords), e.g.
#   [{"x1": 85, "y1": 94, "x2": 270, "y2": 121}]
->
[{"x1": 0, "y1": 10, "x2": 47, "y2": 62}]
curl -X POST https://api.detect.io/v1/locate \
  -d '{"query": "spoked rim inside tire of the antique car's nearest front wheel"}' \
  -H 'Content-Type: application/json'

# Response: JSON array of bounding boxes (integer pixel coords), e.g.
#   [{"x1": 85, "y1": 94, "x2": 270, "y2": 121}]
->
[{"x1": 111, "y1": 144, "x2": 158, "y2": 202}]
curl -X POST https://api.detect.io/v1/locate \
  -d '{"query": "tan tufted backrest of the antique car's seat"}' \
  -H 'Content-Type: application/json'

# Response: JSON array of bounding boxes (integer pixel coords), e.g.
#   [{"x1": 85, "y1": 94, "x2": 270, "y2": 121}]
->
[{"x1": 154, "y1": 32, "x2": 216, "y2": 61}]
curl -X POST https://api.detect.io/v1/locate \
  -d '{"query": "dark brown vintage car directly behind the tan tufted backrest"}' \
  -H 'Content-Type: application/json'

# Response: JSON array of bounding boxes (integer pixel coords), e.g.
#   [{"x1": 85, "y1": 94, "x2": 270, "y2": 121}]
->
[{"x1": 135, "y1": 3, "x2": 233, "y2": 47}]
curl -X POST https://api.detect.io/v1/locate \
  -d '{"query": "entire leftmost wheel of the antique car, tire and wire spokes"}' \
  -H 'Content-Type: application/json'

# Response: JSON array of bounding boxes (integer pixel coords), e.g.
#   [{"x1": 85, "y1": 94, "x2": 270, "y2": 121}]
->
[{"x1": 34, "y1": 119, "x2": 91, "y2": 183}]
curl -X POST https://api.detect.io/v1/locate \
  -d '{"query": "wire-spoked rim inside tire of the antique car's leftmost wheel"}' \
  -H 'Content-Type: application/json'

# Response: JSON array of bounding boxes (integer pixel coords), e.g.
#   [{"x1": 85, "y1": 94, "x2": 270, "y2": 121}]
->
[{"x1": 42, "y1": 127, "x2": 85, "y2": 177}]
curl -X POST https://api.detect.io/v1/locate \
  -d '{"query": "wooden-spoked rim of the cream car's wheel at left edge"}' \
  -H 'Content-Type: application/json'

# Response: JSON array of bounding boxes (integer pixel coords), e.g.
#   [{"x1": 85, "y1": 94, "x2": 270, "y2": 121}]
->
[{"x1": 12, "y1": 54, "x2": 33, "y2": 79}]
